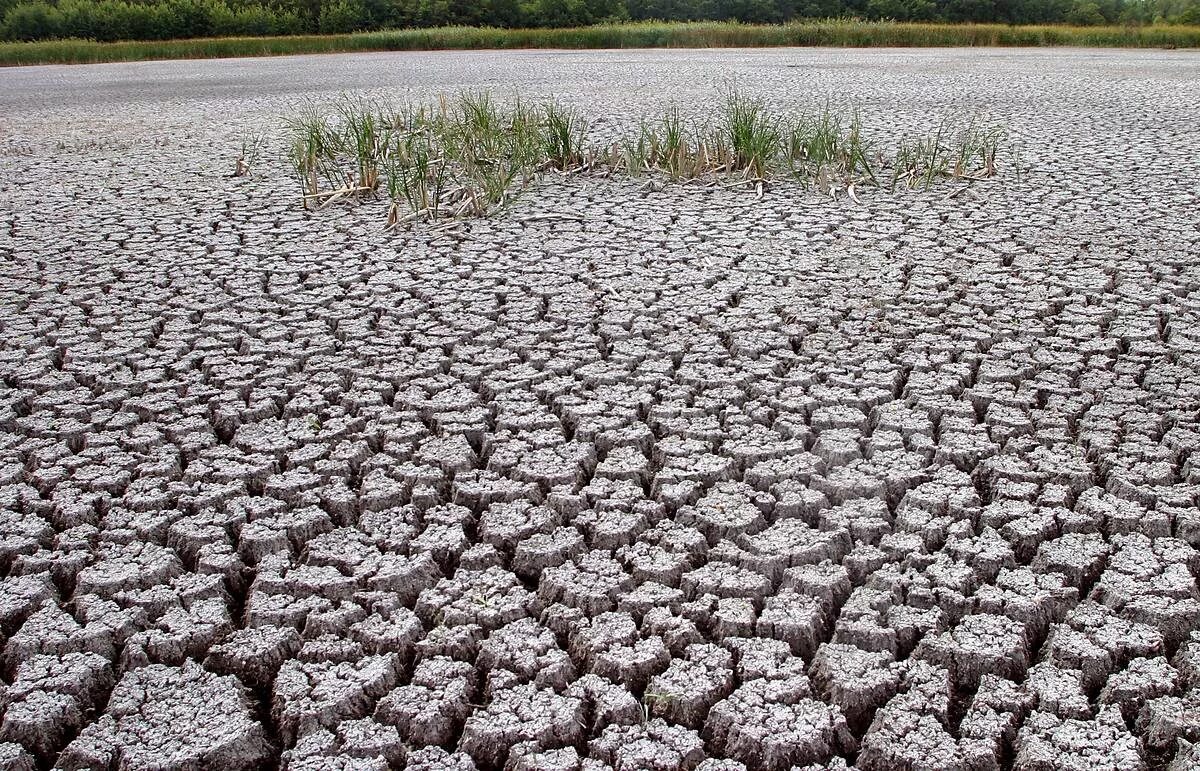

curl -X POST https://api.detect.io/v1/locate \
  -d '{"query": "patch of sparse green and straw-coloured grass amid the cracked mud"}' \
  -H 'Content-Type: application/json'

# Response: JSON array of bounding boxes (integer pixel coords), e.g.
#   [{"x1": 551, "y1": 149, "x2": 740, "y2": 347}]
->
[{"x1": 290, "y1": 90, "x2": 1002, "y2": 227}]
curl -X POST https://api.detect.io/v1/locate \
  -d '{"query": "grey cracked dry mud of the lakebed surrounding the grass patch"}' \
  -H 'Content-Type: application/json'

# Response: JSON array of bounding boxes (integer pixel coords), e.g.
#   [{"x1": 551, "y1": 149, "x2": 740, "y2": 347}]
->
[{"x1": 0, "y1": 50, "x2": 1200, "y2": 771}]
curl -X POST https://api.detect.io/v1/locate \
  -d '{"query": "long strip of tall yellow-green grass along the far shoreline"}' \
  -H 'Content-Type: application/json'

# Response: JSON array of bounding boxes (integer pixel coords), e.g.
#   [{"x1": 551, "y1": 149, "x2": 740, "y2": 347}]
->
[{"x1": 0, "y1": 20, "x2": 1200, "y2": 66}]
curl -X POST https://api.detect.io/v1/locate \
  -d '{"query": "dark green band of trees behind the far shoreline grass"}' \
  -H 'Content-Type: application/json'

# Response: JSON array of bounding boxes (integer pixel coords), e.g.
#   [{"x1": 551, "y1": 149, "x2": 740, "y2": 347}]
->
[{"x1": 0, "y1": 0, "x2": 1200, "y2": 41}]
